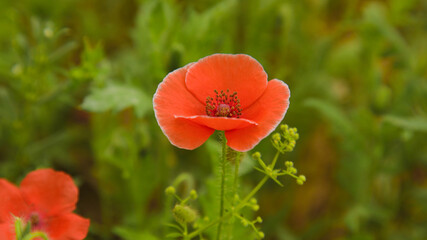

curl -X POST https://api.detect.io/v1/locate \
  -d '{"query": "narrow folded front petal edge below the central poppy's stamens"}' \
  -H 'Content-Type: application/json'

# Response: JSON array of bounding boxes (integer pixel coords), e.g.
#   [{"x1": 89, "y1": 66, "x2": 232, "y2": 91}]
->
[{"x1": 176, "y1": 116, "x2": 257, "y2": 130}]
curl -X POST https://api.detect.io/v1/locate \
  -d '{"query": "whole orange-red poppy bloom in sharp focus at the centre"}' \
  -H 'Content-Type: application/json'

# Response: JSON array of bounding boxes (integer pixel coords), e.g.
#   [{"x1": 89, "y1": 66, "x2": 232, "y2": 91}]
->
[{"x1": 153, "y1": 54, "x2": 290, "y2": 152}]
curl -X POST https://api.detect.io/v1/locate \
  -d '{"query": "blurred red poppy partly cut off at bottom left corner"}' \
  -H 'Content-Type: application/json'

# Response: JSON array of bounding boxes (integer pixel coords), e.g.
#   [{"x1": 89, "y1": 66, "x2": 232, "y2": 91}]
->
[{"x1": 0, "y1": 169, "x2": 89, "y2": 240}]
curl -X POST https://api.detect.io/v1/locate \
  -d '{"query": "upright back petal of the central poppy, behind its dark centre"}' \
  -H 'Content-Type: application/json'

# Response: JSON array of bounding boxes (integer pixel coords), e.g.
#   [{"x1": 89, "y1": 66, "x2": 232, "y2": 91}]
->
[{"x1": 185, "y1": 54, "x2": 267, "y2": 109}]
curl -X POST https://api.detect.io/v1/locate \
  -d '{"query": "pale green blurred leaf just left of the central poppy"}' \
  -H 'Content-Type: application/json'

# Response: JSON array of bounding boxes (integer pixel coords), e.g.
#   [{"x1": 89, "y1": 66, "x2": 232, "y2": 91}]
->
[{"x1": 81, "y1": 84, "x2": 152, "y2": 117}]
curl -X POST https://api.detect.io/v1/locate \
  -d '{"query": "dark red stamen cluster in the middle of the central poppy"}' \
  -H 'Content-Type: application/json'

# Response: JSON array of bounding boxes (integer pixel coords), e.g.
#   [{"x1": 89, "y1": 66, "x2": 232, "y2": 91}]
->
[{"x1": 206, "y1": 90, "x2": 242, "y2": 118}]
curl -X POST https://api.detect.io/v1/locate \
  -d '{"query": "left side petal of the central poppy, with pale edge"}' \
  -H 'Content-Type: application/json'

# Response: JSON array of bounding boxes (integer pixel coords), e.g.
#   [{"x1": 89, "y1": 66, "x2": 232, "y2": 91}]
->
[{"x1": 153, "y1": 64, "x2": 214, "y2": 150}]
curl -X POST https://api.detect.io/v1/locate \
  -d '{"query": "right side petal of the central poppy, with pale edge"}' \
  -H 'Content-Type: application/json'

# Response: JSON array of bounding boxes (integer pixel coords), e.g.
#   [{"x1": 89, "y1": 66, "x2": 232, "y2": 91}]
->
[{"x1": 225, "y1": 79, "x2": 290, "y2": 152}]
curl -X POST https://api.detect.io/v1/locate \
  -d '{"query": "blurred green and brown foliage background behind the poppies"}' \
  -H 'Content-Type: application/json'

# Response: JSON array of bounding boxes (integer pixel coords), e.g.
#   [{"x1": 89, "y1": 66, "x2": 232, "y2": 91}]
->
[{"x1": 0, "y1": 0, "x2": 427, "y2": 240}]
